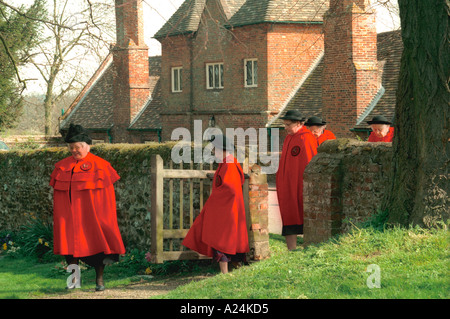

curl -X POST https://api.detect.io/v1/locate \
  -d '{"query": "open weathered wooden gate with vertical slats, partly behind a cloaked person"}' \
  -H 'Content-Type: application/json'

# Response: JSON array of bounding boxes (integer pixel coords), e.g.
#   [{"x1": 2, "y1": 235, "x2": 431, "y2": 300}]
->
[{"x1": 151, "y1": 155, "x2": 249, "y2": 263}]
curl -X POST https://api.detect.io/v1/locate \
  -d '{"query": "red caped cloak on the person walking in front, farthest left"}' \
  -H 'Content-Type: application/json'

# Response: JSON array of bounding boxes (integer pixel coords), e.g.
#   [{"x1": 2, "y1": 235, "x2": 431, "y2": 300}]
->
[{"x1": 50, "y1": 153, "x2": 125, "y2": 257}]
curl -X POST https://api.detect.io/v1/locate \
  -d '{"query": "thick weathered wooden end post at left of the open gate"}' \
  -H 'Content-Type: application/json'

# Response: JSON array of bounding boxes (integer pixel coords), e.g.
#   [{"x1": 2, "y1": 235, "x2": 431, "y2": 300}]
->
[{"x1": 150, "y1": 155, "x2": 164, "y2": 263}]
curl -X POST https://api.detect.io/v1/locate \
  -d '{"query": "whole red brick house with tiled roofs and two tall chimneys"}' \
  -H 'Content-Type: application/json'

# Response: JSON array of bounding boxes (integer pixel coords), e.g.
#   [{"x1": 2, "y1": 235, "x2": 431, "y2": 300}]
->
[{"x1": 60, "y1": 0, "x2": 402, "y2": 143}]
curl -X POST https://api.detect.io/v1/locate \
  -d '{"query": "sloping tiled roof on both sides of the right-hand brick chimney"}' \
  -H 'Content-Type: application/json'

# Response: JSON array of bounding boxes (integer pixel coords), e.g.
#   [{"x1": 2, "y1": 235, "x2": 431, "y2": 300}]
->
[{"x1": 270, "y1": 31, "x2": 403, "y2": 128}]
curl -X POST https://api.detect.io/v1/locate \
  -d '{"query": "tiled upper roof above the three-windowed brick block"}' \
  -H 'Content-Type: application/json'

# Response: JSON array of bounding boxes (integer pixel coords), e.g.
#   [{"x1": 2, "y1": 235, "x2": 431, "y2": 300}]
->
[{"x1": 154, "y1": 0, "x2": 328, "y2": 39}]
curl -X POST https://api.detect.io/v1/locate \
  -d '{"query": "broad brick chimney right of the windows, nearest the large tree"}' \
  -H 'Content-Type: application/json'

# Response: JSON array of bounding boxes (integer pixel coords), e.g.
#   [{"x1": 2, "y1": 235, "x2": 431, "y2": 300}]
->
[{"x1": 322, "y1": 0, "x2": 380, "y2": 137}]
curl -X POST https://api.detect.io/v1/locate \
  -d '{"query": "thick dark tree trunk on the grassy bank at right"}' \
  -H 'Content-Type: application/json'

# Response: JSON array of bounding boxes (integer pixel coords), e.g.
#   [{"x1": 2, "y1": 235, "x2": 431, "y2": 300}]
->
[{"x1": 383, "y1": 0, "x2": 450, "y2": 227}]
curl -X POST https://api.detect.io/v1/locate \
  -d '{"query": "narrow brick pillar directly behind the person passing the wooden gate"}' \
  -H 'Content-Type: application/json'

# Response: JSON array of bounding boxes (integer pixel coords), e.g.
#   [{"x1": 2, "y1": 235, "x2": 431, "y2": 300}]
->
[{"x1": 247, "y1": 164, "x2": 270, "y2": 260}]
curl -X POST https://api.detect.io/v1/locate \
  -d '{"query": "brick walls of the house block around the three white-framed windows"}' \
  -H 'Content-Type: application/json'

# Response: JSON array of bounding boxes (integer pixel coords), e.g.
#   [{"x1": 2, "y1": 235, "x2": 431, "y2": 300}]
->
[{"x1": 157, "y1": 1, "x2": 323, "y2": 139}]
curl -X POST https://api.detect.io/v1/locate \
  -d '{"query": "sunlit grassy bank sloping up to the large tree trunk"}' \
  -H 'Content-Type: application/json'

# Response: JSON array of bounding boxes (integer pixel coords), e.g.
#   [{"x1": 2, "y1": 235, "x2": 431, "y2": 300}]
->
[{"x1": 157, "y1": 228, "x2": 450, "y2": 299}]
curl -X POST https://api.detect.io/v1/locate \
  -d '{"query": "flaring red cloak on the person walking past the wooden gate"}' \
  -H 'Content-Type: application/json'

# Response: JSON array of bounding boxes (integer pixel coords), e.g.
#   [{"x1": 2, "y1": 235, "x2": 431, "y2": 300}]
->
[{"x1": 182, "y1": 156, "x2": 249, "y2": 257}]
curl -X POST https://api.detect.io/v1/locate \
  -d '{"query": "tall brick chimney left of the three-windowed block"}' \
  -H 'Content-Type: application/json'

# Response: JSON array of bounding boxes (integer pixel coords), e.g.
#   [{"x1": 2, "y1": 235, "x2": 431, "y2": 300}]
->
[{"x1": 112, "y1": 0, "x2": 150, "y2": 143}]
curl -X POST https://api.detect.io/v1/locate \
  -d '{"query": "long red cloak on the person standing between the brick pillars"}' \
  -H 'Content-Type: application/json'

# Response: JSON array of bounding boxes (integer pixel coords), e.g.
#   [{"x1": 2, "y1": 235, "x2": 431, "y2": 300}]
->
[{"x1": 276, "y1": 126, "x2": 317, "y2": 234}]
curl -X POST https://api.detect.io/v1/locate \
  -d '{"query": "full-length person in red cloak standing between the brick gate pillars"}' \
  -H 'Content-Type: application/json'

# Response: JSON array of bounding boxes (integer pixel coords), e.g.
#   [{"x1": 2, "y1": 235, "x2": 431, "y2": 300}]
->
[{"x1": 276, "y1": 110, "x2": 317, "y2": 250}]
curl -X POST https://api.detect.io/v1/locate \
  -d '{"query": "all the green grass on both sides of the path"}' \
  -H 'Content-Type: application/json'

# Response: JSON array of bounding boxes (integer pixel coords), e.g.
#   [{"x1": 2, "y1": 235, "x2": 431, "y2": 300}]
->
[{"x1": 0, "y1": 228, "x2": 450, "y2": 299}]
